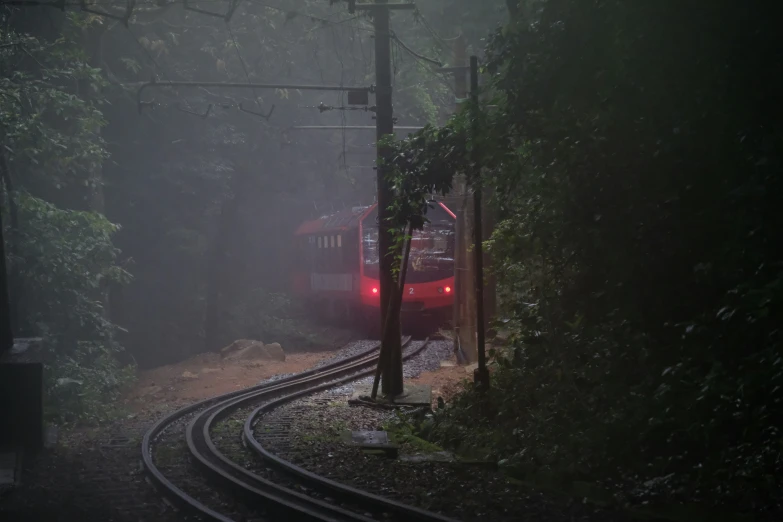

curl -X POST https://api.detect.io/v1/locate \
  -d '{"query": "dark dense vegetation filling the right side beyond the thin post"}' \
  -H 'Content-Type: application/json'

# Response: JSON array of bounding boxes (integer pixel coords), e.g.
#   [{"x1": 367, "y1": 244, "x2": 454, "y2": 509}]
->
[{"x1": 388, "y1": 0, "x2": 783, "y2": 518}]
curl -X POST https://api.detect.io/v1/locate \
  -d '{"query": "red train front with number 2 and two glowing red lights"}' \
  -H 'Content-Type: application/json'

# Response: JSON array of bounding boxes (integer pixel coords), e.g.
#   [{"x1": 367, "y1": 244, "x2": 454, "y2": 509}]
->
[{"x1": 360, "y1": 203, "x2": 455, "y2": 326}]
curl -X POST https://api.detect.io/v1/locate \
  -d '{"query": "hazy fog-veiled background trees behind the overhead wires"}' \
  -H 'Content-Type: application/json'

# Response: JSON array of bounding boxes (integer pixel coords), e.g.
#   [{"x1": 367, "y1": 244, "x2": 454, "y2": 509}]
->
[{"x1": 89, "y1": 0, "x2": 503, "y2": 365}]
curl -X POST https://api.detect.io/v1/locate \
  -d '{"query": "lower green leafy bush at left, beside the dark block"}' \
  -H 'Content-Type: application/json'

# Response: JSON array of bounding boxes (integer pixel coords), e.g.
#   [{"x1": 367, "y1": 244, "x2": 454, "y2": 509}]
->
[{"x1": 5, "y1": 193, "x2": 133, "y2": 422}]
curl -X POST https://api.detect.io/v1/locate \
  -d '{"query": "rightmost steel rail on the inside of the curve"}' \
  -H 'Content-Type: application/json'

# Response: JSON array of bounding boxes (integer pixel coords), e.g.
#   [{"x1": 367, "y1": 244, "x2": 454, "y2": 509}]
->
[{"x1": 243, "y1": 338, "x2": 457, "y2": 522}]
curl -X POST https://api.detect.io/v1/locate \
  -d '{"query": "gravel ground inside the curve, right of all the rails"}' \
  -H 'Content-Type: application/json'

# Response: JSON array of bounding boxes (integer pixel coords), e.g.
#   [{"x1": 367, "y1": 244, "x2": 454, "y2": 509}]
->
[{"x1": 256, "y1": 341, "x2": 624, "y2": 522}]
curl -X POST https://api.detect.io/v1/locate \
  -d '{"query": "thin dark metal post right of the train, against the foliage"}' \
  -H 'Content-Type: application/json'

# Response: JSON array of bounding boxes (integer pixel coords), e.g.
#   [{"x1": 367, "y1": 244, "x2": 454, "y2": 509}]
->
[{"x1": 470, "y1": 56, "x2": 489, "y2": 390}]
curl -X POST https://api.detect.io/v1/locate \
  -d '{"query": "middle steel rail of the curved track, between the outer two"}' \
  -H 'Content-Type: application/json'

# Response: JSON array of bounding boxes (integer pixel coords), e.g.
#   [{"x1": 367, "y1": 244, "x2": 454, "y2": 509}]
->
[{"x1": 185, "y1": 337, "x2": 416, "y2": 522}]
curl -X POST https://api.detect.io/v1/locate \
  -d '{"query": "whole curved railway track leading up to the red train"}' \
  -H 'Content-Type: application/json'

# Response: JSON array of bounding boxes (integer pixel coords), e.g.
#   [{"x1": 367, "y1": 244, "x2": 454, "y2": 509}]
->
[{"x1": 142, "y1": 337, "x2": 460, "y2": 522}]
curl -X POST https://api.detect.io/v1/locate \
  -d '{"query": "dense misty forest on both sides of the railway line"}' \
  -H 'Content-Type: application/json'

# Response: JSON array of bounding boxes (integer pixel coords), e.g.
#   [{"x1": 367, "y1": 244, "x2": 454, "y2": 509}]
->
[{"x1": 0, "y1": 0, "x2": 783, "y2": 519}]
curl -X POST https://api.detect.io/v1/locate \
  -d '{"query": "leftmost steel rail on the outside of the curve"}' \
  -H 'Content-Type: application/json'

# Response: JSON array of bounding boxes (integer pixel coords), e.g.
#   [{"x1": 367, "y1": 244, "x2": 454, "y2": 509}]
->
[{"x1": 141, "y1": 343, "x2": 388, "y2": 522}]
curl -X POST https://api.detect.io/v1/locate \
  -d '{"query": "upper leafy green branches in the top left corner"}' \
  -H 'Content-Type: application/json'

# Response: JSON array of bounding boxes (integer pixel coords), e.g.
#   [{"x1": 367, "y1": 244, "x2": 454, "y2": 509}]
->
[{"x1": 0, "y1": 18, "x2": 107, "y2": 188}]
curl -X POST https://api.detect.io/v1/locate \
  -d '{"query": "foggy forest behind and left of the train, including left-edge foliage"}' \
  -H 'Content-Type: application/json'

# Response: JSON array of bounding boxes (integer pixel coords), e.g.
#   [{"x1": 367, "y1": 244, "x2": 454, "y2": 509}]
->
[{"x1": 0, "y1": 0, "x2": 496, "y2": 414}]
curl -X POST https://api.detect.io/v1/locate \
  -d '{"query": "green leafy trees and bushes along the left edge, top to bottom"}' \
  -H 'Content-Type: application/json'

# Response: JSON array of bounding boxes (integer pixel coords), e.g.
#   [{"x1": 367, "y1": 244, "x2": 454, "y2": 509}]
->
[{"x1": 0, "y1": 17, "x2": 133, "y2": 422}]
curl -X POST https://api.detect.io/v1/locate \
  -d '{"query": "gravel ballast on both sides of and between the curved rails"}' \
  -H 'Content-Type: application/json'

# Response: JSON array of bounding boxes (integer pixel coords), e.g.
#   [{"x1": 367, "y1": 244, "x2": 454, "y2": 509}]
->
[{"x1": 0, "y1": 340, "x2": 636, "y2": 522}]
